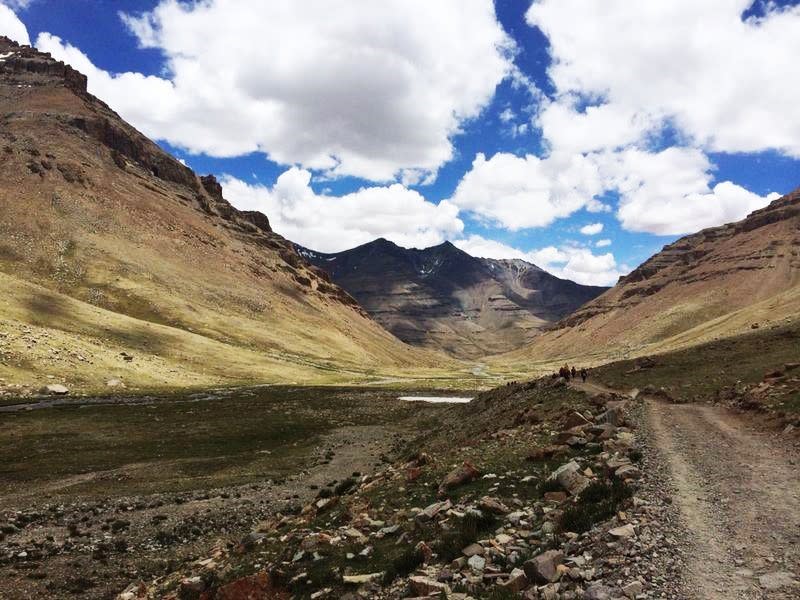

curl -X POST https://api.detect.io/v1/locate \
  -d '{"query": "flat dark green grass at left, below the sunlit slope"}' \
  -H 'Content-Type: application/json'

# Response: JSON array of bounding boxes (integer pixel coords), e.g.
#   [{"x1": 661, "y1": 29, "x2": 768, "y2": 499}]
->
[{"x1": 0, "y1": 387, "x2": 432, "y2": 495}]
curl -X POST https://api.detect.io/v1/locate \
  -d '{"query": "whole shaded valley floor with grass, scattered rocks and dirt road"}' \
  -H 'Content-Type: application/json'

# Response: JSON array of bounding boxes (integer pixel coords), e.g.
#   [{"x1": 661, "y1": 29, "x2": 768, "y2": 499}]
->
[{"x1": 0, "y1": 328, "x2": 800, "y2": 600}]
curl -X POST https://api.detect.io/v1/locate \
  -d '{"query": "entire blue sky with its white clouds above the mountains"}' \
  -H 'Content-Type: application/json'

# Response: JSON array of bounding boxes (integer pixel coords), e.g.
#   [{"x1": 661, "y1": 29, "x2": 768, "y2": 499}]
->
[{"x1": 0, "y1": 0, "x2": 800, "y2": 284}]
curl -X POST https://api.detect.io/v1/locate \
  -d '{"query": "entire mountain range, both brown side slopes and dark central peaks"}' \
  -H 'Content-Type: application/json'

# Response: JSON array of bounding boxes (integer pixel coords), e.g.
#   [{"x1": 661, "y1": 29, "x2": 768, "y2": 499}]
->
[{"x1": 0, "y1": 38, "x2": 800, "y2": 389}]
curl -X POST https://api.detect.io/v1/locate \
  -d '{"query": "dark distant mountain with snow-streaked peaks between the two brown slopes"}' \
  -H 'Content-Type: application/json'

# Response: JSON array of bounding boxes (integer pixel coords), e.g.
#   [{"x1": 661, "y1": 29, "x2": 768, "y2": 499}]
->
[{"x1": 298, "y1": 239, "x2": 605, "y2": 358}]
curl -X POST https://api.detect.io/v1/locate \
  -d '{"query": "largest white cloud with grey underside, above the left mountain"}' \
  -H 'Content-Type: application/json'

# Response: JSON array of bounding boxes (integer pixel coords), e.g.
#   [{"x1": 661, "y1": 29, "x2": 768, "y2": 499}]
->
[{"x1": 37, "y1": 0, "x2": 514, "y2": 181}]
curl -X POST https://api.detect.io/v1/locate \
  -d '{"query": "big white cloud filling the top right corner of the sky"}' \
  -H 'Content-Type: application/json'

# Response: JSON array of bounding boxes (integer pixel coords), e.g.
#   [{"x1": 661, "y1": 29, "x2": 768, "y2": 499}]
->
[{"x1": 527, "y1": 0, "x2": 800, "y2": 156}]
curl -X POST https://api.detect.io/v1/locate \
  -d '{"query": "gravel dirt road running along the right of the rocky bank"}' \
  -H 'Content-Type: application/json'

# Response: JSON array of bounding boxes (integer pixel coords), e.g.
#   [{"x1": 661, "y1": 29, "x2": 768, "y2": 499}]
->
[{"x1": 572, "y1": 380, "x2": 800, "y2": 600}]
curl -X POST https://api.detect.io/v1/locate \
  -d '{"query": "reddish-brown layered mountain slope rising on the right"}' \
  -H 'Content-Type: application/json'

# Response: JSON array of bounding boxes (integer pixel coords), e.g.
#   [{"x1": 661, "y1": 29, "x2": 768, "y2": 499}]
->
[{"x1": 505, "y1": 189, "x2": 800, "y2": 362}]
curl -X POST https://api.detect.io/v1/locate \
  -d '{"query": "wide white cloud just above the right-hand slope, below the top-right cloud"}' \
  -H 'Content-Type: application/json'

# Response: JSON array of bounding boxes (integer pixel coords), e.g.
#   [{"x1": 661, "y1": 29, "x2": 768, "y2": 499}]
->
[{"x1": 452, "y1": 147, "x2": 779, "y2": 235}]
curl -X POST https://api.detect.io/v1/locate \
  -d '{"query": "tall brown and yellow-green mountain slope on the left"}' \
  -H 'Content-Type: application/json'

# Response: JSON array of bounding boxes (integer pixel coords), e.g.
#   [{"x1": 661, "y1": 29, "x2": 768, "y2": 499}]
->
[{"x1": 0, "y1": 38, "x2": 450, "y2": 394}]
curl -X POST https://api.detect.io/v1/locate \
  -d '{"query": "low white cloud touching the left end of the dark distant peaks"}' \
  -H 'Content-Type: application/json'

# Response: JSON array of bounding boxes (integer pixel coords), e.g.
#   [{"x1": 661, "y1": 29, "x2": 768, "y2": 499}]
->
[{"x1": 221, "y1": 167, "x2": 464, "y2": 252}]
